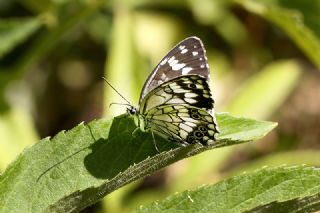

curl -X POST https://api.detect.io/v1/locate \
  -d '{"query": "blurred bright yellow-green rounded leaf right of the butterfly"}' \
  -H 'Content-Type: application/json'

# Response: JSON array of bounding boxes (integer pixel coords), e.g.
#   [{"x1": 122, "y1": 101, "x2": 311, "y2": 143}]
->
[{"x1": 227, "y1": 60, "x2": 301, "y2": 119}]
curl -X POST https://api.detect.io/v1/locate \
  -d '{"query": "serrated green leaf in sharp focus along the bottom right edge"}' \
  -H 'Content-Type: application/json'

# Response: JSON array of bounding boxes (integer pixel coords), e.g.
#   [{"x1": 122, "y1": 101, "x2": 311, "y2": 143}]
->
[{"x1": 135, "y1": 166, "x2": 320, "y2": 212}]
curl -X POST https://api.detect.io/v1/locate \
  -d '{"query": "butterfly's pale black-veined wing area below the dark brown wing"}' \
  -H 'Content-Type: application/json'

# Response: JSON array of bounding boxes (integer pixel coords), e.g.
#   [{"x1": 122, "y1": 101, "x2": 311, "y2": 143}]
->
[{"x1": 139, "y1": 75, "x2": 218, "y2": 145}]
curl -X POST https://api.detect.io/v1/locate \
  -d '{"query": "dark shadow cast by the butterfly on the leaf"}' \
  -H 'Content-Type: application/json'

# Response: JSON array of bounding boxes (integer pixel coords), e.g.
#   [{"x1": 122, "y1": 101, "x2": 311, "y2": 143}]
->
[{"x1": 84, "y1": 117, "x2": 178, "y2": 179}]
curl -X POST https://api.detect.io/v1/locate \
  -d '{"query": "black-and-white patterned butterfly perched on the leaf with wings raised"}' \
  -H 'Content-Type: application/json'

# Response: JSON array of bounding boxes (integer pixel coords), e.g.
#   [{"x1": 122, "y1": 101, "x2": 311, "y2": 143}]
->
[{"x1": 127, "y1": 37, "x2": 219, "y2": 145}]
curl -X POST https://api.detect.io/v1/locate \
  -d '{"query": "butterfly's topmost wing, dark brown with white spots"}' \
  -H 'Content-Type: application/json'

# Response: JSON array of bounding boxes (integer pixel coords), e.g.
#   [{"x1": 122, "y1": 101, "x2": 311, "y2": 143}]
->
[{"x1": 140, "y1": 37, "x2": 210, "y2": 103}]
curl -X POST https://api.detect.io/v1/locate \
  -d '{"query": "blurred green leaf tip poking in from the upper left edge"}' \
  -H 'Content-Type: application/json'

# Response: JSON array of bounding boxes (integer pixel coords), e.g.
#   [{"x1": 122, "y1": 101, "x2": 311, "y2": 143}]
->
[{"x1": 0, "y1": 18, "x2": 41, "y2": 58}]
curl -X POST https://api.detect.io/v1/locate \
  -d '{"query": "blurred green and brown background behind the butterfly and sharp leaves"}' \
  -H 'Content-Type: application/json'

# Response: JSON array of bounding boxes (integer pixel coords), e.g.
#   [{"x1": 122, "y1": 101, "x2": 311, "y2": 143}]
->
[{"x1": 0, "y1": 0, "x2": 320, "y2": 212}]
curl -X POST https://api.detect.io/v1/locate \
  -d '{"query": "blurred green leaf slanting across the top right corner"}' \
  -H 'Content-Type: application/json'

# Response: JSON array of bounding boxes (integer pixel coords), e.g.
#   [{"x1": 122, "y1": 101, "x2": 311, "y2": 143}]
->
[{"x1": 234, "y1": 0, "x2": 320, "y2": 68}]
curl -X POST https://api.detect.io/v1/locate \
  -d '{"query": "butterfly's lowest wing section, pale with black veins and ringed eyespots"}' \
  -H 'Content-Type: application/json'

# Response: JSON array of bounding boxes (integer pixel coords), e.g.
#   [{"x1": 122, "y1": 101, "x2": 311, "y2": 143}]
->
[{"x1": 145, "y1": 105, "x2": 218, "y2": 145}]
